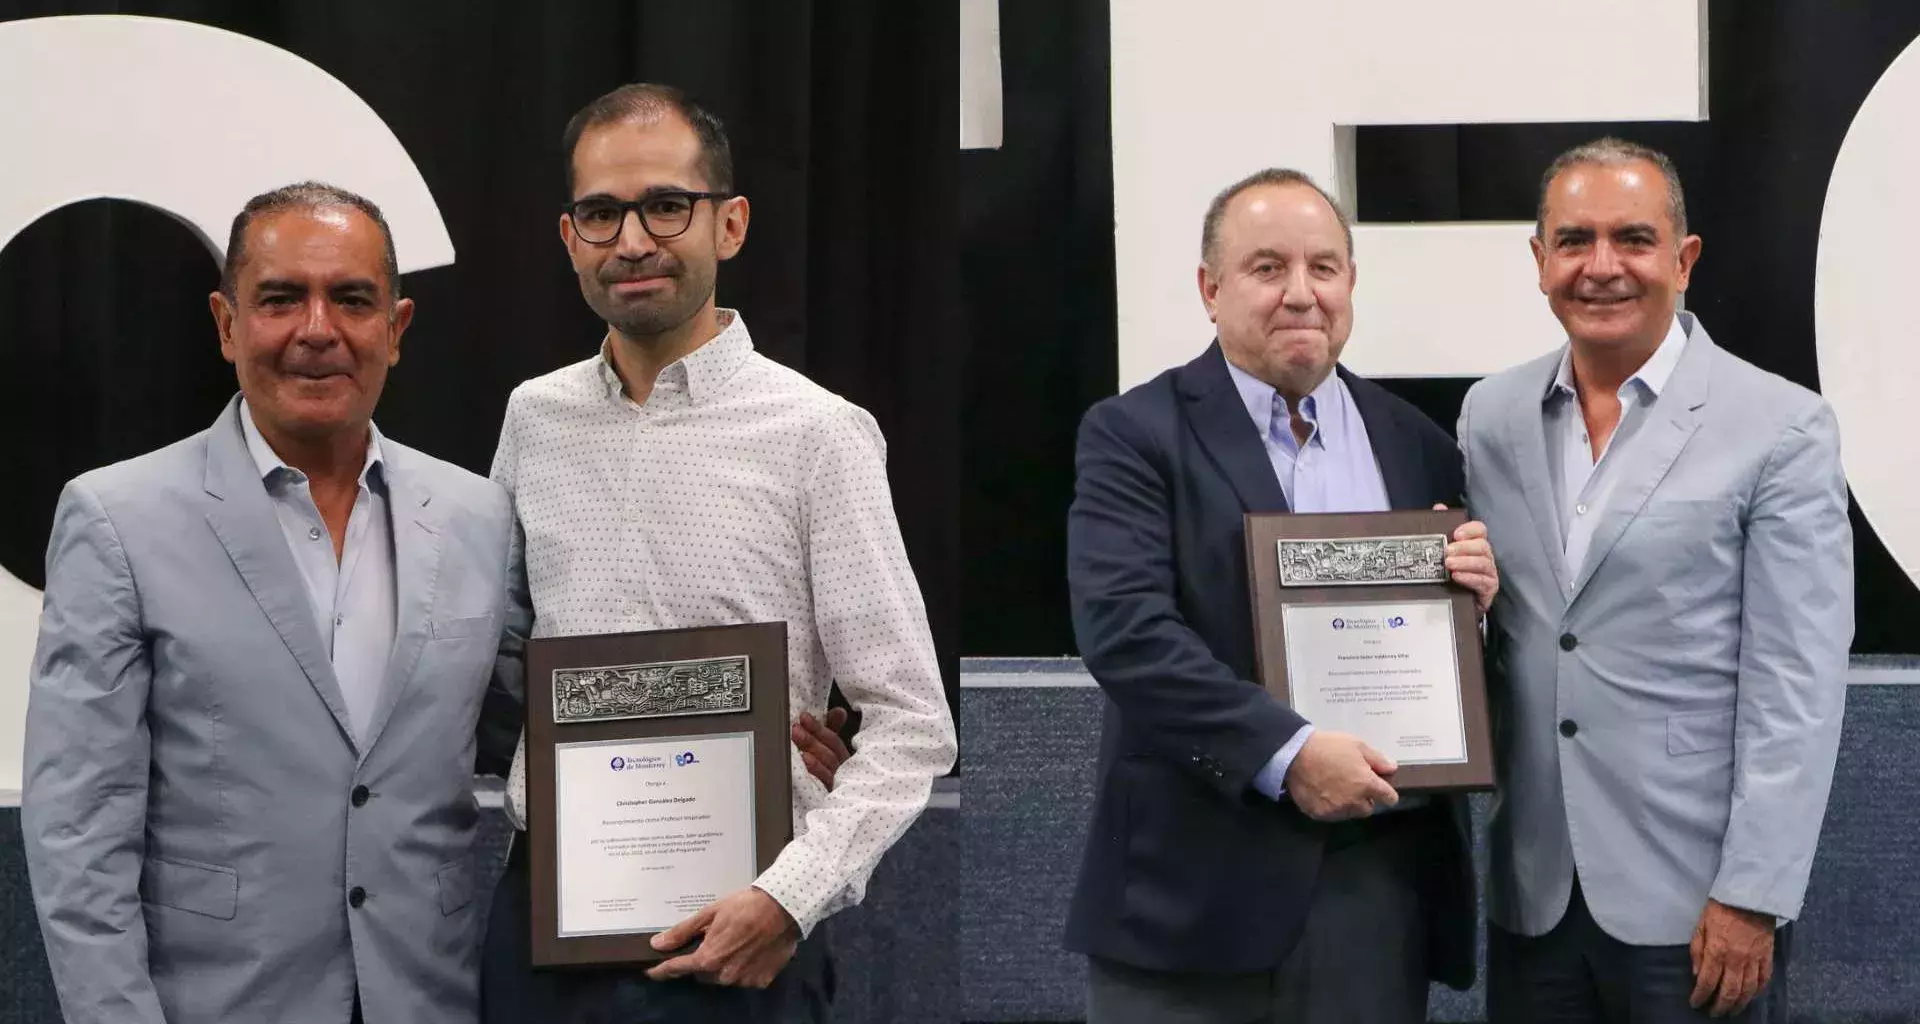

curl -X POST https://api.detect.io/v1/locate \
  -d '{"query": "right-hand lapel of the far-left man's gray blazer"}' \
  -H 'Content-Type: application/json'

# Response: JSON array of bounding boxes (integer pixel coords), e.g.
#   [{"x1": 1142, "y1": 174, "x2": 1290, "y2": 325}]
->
[{"x1": 361, "y1": 442, "x2": 442, "y2": 759}]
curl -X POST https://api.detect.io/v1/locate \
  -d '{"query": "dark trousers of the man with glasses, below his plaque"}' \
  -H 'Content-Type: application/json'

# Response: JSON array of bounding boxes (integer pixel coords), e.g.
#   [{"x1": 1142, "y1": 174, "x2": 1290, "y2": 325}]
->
[{"x1": 480, "y1": 836, "x2": 833, "y2": 1024}]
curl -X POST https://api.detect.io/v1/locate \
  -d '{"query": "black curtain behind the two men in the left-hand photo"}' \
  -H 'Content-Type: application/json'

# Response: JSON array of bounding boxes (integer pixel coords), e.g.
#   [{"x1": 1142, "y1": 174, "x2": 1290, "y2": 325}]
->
[{"x1": 0, "y1": 0, "x2": 964, "y2": 699}]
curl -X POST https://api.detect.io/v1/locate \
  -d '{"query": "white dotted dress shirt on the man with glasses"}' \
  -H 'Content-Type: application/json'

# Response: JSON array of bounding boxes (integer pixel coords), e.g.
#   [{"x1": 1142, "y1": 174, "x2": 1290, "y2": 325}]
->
[{"x1": 493, "y1": 309, "x2": 956, "y2": 934}]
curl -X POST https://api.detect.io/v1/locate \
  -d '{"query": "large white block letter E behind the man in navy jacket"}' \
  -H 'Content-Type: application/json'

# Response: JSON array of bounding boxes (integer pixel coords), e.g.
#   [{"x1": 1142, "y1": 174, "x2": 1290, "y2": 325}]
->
[{"x1": 1112, "y1": 0, "x2": 1707, "y2": 388}]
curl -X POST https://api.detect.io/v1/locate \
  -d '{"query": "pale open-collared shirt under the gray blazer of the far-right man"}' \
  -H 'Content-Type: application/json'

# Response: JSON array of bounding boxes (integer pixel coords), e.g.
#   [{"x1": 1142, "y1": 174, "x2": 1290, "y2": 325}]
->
[{"x1": 1544, "y1": 317, "x2": 1686, "y2": 590}]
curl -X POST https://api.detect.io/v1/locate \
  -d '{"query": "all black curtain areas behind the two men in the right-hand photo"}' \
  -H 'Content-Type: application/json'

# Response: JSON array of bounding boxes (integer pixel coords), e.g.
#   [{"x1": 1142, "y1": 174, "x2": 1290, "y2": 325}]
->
[{"x1": 962, "y1": 0, "x2": 1920, "y2": 655}]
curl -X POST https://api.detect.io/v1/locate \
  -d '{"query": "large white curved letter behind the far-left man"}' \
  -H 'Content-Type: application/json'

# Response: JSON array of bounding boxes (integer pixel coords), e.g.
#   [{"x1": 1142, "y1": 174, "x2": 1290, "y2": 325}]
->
[{"x1": 0, "y1": 15, "x2": 453, "y2": 801}]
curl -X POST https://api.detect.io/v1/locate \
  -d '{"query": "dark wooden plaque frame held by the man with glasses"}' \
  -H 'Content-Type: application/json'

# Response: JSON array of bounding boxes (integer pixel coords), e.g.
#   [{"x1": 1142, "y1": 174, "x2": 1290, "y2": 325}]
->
[{"x1": 526, "y1": 622, "x2": 793, "y2": 966}]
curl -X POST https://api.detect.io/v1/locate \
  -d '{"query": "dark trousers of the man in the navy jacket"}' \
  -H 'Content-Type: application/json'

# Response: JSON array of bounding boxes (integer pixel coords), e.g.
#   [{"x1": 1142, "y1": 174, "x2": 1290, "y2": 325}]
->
[{"x1": 1087, "y1": 813, "x2": 1428, "y2": 1024}]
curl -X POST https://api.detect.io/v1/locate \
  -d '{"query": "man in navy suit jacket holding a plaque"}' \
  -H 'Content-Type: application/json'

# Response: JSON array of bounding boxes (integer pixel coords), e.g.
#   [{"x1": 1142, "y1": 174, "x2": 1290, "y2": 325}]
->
[{"x1": 1068, "y1": 171, "x2": 1498, "y2": 1024}]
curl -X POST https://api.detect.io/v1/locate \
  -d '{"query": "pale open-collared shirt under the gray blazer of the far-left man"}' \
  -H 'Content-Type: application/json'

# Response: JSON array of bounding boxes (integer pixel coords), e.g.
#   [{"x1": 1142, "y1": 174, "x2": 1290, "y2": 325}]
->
[{"x1": 240, "y1": 400, "x2": 397, "y2": 742}]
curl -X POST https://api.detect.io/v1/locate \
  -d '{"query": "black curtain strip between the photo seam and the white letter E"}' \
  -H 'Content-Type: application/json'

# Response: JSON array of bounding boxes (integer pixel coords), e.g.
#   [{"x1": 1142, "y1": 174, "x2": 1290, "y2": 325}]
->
[{"x1": 960, "y1": 0, "x2": 1113, "y2": 657}]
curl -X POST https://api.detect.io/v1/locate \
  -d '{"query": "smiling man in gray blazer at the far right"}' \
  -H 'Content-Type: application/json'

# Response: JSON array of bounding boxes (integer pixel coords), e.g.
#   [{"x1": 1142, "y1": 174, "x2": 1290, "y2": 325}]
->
[{"x1": 1459, "y1": 138, "x2": 1853, "y2": 1024}]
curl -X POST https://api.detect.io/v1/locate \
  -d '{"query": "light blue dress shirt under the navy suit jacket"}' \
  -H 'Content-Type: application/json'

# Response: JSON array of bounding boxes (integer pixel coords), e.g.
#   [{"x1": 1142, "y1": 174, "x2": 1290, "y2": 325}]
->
[{"x1": 1227, "y1": 359, "x2": 1407, "y2": 805}]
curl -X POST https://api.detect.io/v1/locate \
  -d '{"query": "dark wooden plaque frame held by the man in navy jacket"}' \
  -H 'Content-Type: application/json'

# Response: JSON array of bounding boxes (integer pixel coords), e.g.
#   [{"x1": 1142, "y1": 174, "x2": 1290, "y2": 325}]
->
[{"x1": 1246, "y1": 509, "x2": 1494, "y2": 793}]
